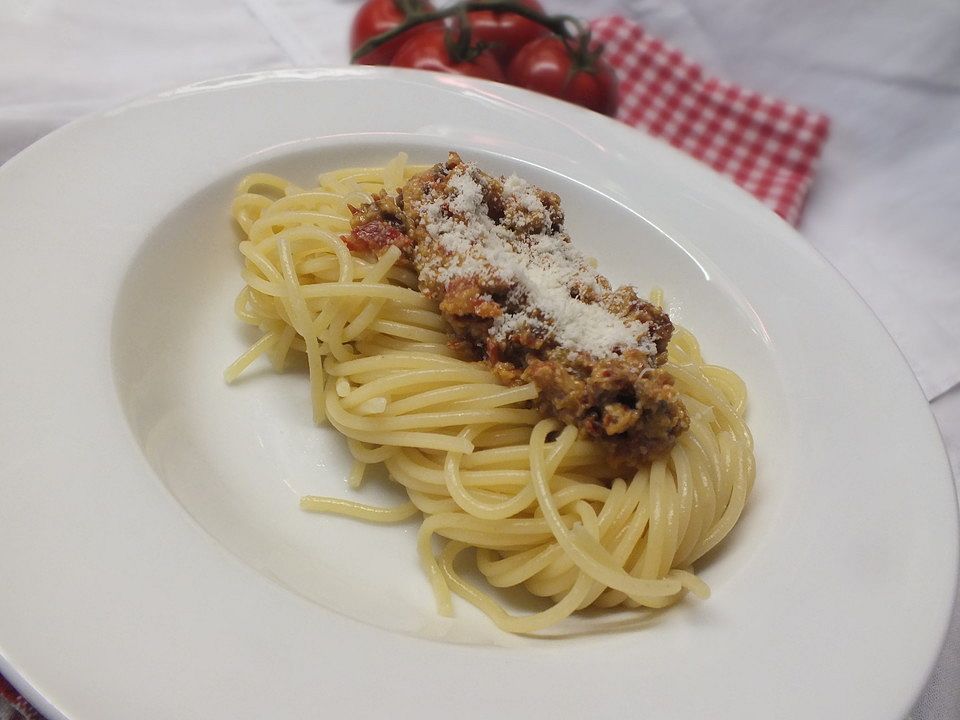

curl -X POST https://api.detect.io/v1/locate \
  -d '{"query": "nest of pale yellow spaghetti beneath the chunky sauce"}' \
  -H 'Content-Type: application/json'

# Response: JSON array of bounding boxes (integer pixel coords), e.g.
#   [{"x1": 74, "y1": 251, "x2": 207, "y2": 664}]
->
[{"x1": 226, "y1": 155, "x2": 754, "y2": 633}]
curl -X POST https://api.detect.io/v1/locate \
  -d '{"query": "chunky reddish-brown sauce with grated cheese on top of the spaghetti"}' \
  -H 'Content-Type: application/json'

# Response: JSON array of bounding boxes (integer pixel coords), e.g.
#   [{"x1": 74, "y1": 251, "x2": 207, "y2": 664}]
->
[{"x1": 347, "y1": 153, "x2": 689, "y2": 468}]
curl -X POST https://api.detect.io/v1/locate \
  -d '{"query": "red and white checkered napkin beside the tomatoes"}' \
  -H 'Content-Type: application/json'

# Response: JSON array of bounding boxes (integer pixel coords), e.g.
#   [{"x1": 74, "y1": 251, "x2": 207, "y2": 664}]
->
[{"x1": 590, "y1": 17, "x2": 830, "y2": 224}]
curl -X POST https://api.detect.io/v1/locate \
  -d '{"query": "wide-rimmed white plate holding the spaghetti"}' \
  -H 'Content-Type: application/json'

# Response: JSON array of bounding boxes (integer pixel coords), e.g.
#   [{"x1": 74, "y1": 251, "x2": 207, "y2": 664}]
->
[{"x1": 0, "y1": 68, "x2": 957, "y2": 720}]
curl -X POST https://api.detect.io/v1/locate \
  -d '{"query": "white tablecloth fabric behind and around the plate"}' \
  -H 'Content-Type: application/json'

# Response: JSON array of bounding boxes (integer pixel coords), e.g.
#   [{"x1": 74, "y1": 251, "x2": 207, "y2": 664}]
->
[{"x1": 0, "y1": 0, "x2": 960, "y2": 720}]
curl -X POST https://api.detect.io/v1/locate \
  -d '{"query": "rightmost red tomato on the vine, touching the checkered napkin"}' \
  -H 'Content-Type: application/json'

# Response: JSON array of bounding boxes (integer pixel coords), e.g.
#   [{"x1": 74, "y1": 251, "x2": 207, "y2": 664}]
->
[{"x1": 507, "y1": 35, "x2": 617, "y2": 116}]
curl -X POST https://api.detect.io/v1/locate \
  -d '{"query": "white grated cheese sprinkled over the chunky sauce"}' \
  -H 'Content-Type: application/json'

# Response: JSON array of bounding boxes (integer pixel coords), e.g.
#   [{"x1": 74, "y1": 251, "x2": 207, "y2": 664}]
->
[{"x1": 408, "y1": 164, "x2": 656, "y2": 357}]
